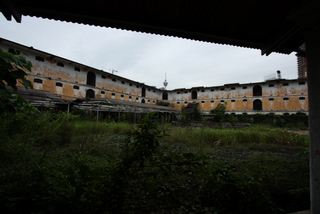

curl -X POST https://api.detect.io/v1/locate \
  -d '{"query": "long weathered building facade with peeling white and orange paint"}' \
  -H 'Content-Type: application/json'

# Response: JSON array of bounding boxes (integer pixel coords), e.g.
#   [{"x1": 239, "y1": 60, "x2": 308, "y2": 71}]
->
[{"x1": 0, "y1": 39, "x2": 308, "y2": 114}]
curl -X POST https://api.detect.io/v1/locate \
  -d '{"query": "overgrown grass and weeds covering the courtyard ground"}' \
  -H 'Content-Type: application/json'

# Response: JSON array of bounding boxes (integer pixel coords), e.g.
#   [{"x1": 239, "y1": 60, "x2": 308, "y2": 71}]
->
[{"x1": 0, "y1": 112, "x2": 309, "y2": 213}]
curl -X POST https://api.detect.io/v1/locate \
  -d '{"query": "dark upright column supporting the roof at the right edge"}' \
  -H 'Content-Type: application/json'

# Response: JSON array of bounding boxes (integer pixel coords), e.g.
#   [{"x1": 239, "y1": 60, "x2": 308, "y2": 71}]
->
[{"x1": 305, "y1": 29, "x2": 320, "y2": 214}]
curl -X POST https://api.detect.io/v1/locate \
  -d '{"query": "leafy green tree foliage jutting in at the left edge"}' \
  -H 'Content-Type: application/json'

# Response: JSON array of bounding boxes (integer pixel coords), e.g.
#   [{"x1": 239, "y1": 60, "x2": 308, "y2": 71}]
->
[{"x1": 0, "y1": 49, "x2": 32, "y2": 115}]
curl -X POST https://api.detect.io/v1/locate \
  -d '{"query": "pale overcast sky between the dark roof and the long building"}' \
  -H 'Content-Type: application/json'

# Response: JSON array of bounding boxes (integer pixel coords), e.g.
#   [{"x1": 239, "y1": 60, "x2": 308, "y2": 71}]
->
[{"x1": 0, "y1": 14, "x2": 297, "y2": 90}]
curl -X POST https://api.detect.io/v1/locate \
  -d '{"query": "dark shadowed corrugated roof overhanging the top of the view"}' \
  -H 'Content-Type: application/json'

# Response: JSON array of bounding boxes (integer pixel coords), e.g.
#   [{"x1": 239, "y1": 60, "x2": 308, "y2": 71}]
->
[{"x1": 0, "y1": 0, "x2": 320, "y2": 53}]
